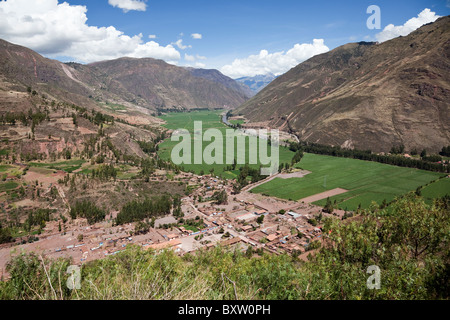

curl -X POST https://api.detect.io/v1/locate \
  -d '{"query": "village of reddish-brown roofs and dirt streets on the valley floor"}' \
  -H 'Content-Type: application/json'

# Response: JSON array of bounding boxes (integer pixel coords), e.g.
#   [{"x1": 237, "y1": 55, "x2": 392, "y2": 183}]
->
[{"x1": 0, "y1": 168, "x2": 343, "y2": 277}]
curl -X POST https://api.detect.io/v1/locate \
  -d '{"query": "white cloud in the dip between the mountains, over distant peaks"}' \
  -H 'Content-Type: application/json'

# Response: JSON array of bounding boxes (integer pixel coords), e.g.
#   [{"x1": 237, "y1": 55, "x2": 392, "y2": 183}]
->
[{"x1": 220, "y1": 39, "x2": 330, "y2": 79}]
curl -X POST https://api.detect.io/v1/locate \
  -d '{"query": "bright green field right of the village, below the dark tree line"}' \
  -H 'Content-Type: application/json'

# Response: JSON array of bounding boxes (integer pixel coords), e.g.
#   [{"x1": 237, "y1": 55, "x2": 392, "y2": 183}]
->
[{"x1": 252, "y1": 154, "x2": 442, "y2": 210}]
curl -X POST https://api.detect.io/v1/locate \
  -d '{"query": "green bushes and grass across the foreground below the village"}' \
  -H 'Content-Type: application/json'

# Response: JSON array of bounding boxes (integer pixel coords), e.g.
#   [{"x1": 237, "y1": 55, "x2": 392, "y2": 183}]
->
[{"x1": 0, "y1": 194, "x2": 450, "y2": 300}]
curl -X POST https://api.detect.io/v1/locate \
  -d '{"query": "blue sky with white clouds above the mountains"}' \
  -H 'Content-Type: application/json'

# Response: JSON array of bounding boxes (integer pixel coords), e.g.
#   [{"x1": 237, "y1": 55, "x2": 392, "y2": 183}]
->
[{"x1": 0, "y1": 0, "x2": 450, "y2": 78}]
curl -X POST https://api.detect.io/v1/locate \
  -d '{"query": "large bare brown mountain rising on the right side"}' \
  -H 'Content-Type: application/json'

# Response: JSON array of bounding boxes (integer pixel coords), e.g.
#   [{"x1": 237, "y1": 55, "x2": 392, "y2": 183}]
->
[{"x1": 234, "y1": 16, "x2": 450, "y2": 151}]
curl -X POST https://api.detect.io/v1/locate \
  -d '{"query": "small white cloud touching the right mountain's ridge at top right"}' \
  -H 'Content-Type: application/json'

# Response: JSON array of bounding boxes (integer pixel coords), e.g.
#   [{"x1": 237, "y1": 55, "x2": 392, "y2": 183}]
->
[{"x1": 375, "y1": 9, "x2": 440, "y2": 42}]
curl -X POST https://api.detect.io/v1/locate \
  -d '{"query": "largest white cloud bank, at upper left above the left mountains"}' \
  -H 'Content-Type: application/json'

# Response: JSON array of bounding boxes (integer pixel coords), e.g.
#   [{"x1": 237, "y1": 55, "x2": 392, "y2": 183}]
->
[{"x1": 0, "y1": 0, "x2": 181, "y2": 63}]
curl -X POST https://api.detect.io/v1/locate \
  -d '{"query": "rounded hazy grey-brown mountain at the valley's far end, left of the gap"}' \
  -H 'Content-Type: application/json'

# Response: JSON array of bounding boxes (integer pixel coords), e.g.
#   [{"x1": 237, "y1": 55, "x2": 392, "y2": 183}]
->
[{"x1": 85, "y1": 58, "x2": 248, "y2": 110}]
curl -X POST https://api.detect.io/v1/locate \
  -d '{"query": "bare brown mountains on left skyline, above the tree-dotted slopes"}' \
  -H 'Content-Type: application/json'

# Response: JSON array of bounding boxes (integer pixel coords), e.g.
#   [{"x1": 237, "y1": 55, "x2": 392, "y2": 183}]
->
[{"x1": 0, "y1": 40, "x2": 251, "y2": 111}]
